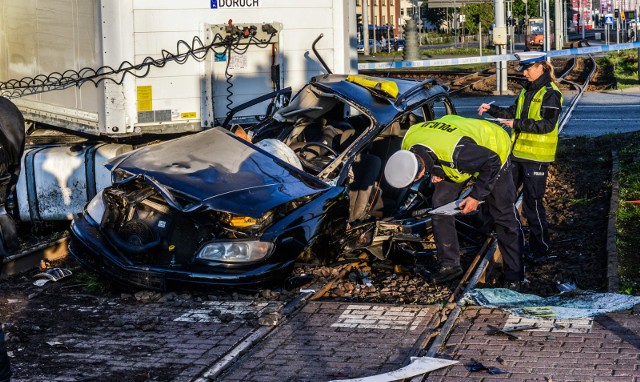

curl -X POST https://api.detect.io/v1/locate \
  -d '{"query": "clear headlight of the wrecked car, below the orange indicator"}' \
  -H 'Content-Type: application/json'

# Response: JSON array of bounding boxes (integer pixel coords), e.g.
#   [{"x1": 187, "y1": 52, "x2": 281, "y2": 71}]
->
[{"x1": 196, "y1": 241, "x2": 273, "y2": 263}]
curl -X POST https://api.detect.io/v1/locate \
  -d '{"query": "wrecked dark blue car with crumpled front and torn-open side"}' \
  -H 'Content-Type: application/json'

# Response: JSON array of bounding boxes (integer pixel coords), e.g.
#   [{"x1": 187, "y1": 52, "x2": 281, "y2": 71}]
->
[{"x1": 70, "y1": 74, "x2": 455, "y2": 290}]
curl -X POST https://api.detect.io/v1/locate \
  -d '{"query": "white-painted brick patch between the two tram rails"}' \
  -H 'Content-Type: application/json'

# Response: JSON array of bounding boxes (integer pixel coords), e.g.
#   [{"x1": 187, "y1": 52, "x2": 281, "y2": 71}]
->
[{"x1": 331, "y1": 305, "x2": 429, "y2": 330}]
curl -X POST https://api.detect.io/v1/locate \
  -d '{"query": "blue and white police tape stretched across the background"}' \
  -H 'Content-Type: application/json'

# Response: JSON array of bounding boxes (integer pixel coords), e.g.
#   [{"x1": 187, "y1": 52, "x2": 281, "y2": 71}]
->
[{"x1": 358, "y1": 42, "x2": 640, "y2": 70}]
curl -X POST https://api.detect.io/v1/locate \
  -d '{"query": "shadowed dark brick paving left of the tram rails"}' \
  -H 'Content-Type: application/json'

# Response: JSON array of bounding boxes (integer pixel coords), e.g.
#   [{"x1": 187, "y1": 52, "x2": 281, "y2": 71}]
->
[{"x1": 5, "y1": 296, "x2": 282, "y2": 382}]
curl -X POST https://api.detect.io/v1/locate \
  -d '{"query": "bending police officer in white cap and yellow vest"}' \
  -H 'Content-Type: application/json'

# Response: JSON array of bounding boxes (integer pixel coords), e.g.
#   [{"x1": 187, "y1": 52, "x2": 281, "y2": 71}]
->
[{"x1": 384, "y1": 115, "x2": 524, "y2": 289}]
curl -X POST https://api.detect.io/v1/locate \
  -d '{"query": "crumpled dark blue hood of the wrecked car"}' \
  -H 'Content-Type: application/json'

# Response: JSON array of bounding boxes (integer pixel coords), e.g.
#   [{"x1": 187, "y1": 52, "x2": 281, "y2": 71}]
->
[{"x1": 106, "y1": 128, "x2": 329, "y2": 218}]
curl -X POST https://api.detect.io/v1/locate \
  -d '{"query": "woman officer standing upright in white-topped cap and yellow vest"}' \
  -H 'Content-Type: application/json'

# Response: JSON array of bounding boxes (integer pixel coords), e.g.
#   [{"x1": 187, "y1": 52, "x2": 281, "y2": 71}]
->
[{"x1": 478, "y1": 52, "x2": 563, "y2": 262}]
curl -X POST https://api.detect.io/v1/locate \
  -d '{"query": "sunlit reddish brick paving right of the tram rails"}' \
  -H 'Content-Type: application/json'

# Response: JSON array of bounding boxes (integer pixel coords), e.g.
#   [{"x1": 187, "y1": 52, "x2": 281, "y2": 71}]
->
[{"x1": 427, "y1": 306, "x2": 640, "y2": 381}]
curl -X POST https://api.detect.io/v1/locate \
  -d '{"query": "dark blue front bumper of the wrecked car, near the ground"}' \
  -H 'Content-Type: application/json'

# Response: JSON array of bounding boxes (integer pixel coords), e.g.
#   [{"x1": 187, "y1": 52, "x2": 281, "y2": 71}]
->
[{"x1": 69, "y1": 215, "x2": 295, "y2": 291}]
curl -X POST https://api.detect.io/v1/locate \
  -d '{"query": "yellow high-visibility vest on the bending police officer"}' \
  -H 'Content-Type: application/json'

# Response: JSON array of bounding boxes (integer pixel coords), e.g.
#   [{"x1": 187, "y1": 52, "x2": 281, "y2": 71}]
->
[{"x1": 402, "y1": 115, "x2": 511, "y2": 183}]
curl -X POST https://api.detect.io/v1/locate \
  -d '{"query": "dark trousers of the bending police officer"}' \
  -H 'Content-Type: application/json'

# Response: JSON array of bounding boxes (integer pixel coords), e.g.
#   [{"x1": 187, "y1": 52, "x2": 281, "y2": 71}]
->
[{"x1": 432, "y1": 158, "x2": 524, "y2": 281}]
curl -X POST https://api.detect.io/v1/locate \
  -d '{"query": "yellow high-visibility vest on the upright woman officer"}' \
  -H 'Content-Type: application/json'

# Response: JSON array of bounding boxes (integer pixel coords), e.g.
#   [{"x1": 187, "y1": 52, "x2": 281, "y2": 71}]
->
[{"x1": 512, "y1": 82, "x2": 563, "y2": 162}]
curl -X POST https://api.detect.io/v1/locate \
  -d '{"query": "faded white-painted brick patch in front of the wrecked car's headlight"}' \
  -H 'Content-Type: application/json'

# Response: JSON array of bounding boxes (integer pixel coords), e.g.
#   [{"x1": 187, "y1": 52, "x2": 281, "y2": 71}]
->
[{"x1": 173, "y1": 301, "x2": 269, "y2": 323}]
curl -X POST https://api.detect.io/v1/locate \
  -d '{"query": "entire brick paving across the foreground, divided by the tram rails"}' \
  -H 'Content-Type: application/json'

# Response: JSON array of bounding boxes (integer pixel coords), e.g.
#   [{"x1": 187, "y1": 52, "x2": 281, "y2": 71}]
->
[{"x1": 9, "y1": 286, "x2": 640, "y2": 382}]
